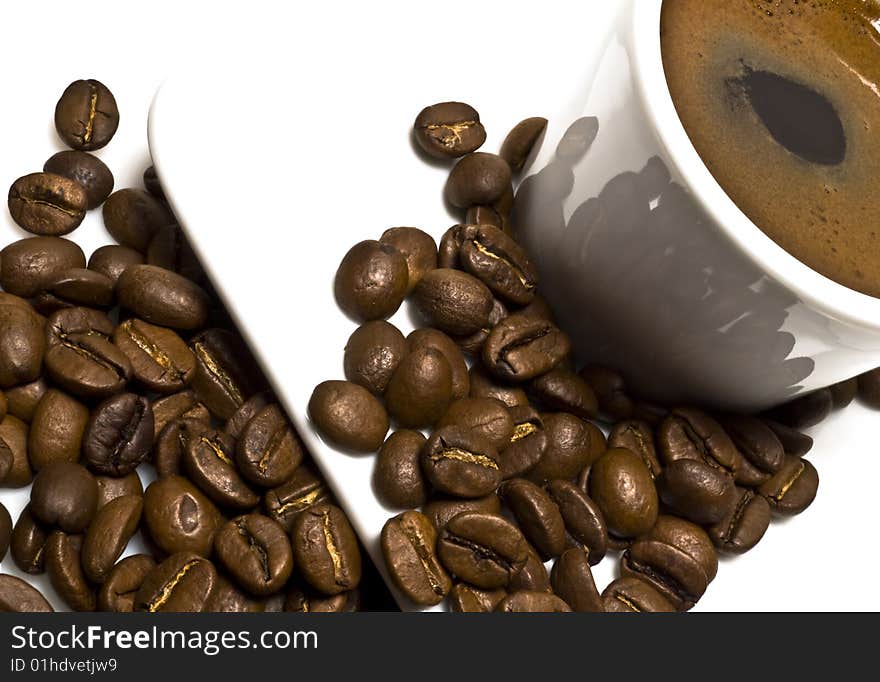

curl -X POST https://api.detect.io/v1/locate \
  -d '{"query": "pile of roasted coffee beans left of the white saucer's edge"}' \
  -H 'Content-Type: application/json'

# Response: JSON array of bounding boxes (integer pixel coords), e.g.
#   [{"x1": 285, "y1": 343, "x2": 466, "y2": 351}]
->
[{"x1": 0, "y1": 80, "x2": 393, "y2": 612}]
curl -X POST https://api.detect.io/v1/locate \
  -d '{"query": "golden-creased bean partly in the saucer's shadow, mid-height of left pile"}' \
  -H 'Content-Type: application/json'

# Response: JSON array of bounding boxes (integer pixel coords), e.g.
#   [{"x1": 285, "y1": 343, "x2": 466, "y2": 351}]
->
[{"x1": 189, "y1": 329, "x2": 259, "y2": 419}]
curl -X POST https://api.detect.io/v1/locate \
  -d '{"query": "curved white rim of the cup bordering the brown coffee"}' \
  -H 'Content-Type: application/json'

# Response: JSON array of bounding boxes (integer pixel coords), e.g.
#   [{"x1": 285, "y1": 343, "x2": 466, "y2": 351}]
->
[{"x1": 630, "y1": 0, "x2": 880, "y2": 331}]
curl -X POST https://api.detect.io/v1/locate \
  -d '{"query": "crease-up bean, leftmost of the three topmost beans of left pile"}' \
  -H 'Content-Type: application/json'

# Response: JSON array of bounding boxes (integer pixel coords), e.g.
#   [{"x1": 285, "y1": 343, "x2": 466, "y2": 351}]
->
[{"x1": 8, "y1": 173, "x2": 88, "y2": 237}]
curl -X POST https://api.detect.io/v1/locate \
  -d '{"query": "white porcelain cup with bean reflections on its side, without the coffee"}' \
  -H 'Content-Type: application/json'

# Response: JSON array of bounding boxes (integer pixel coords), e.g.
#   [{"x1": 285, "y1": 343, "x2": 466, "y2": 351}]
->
[{"x1": 514, "y1": 0, "x2": 880, "y2": 411}]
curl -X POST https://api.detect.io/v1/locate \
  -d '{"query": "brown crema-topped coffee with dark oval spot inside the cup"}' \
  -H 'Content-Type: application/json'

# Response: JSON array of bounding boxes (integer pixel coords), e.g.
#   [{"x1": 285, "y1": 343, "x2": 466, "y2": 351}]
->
[{"x1": 661, "y1": 0, "x2": 880, "y2": 297}]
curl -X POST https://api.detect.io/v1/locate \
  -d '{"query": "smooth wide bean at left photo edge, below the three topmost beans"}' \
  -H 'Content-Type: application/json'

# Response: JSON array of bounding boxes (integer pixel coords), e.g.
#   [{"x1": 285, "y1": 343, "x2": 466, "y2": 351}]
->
[{"x1": 0, "y1": 237, "x2": 86, "y2": 298}]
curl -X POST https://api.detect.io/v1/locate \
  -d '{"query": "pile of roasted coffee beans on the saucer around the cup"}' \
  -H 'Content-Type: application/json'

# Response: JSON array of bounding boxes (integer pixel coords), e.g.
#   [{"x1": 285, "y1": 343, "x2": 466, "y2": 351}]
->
[{"x1": 309, "y1": 102, "x2": 868, "y2": 612}]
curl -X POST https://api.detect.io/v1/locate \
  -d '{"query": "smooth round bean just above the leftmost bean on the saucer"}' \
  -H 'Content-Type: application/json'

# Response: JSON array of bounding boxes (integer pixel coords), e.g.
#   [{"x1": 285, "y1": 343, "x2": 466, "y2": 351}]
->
[{"x1": 343, "y1": 320, "x2": 407, "y2": 395}]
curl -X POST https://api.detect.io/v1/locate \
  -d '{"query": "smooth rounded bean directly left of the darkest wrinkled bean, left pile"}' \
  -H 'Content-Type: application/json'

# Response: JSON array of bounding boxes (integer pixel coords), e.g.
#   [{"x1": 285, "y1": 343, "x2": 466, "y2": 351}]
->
[{"x1": 28, "y1": 388, "x2": 89, "y2": 471}]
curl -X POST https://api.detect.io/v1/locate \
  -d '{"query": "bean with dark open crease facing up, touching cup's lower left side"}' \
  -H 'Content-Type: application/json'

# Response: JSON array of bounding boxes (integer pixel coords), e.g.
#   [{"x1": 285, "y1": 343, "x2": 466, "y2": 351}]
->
[{"x1": 483, "y1": 315, "x2": 571, "y2": 381}]
